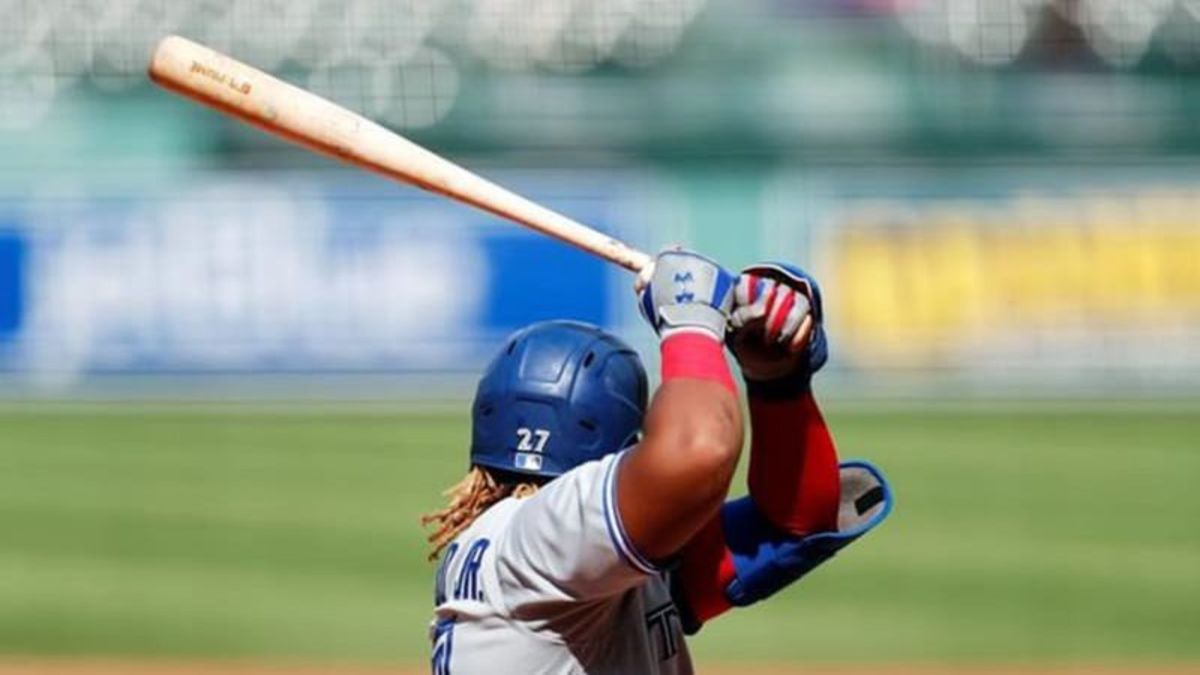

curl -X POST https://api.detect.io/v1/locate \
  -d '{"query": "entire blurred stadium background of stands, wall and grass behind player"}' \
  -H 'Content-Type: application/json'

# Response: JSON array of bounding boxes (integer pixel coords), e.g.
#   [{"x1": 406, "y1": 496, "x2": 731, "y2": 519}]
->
[{"x1": 0, "y1": 0, "x2": 1200, "y2": 671}]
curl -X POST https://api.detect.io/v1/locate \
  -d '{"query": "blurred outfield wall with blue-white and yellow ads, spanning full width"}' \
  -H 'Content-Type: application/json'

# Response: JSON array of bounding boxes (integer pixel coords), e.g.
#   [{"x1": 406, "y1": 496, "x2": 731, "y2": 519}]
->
[{"x1": 0, "y1": 167, "x2": 1200, "y2": 396}]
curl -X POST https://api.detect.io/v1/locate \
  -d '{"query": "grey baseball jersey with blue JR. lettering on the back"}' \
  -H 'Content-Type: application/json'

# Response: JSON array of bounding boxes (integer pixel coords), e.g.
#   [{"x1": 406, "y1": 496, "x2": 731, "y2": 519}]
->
[{"x1": 430, "y1": 446, "x2": 692, "y2": 675}]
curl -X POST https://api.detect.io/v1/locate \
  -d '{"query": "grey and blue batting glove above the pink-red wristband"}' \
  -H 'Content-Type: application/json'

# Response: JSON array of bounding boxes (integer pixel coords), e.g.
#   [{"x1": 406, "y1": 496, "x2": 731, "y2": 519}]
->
[{"x1": 637, "y1": 250, "x2": 736, "y2": 341}]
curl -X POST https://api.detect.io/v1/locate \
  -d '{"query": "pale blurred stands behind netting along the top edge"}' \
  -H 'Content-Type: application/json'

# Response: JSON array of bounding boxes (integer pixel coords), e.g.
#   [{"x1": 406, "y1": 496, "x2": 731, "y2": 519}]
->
[{"x1": 0, "y1": 0, "x2": 1200, "y2": 127}]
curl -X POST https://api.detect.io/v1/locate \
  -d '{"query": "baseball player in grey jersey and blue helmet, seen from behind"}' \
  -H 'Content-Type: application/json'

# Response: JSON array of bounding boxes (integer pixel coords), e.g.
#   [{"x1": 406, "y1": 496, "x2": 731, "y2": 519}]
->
[{"x1": 424, "y1": 251, "x2": 892, "y2": 675}]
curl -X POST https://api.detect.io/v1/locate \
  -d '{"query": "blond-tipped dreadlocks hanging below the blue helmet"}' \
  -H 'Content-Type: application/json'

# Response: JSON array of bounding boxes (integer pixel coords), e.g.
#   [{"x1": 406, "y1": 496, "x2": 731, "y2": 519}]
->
[{"x1": 421, "y1": 466, "x2": 545, "y2": 562}]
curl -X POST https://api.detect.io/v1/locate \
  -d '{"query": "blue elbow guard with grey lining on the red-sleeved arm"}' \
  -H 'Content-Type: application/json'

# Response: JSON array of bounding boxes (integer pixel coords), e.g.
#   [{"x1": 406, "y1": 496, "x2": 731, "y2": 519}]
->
[{"x1": 721, "y1": 461, "x2": 892, "y2": 607}]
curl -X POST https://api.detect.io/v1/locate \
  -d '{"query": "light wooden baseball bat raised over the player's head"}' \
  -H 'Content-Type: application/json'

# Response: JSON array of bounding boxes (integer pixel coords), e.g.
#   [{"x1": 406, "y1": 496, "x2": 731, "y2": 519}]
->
[{"x1": 149, "y1": 35, "x2": 653, "y2": 275}]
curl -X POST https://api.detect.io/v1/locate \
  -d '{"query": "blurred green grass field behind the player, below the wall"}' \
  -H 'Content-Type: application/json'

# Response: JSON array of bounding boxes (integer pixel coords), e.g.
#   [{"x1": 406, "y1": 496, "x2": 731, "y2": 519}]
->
[{"x1": 0, "y1": 404, "x2": 1200, "y2": 663}]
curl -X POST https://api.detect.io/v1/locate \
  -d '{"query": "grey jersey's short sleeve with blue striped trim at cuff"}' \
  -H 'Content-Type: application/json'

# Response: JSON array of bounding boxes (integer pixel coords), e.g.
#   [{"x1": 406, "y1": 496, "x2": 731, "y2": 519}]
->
[{"x1": 497, "y1": 453, "x2": 659, "y2": 600}]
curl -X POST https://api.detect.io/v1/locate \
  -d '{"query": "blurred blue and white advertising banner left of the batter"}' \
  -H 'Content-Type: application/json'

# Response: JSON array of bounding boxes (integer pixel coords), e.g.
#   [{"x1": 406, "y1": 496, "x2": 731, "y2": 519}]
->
[{"x1": 0, "y1": 172, "x2": 644, "y2": 387}]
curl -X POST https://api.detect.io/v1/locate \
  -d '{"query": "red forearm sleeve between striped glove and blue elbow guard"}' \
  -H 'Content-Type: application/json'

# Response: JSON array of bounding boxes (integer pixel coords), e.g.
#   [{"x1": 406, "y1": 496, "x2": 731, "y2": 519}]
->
[{"x1": 749, "y1": 392, "x2": 841, "y2": 534}]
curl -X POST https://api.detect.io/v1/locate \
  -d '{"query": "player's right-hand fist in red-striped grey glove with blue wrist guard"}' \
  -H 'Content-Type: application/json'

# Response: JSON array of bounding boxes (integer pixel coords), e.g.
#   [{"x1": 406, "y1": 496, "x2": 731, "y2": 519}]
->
[{"x1": 730, "y1": 263, "x2": 829, "y2": 390}]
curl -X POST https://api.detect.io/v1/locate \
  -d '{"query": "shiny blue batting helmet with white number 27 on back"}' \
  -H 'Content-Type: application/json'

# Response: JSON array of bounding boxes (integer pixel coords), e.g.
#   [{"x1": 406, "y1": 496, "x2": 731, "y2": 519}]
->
[{"x1": 470, "y1": 321, "x2": 647, "y2": 478}]
